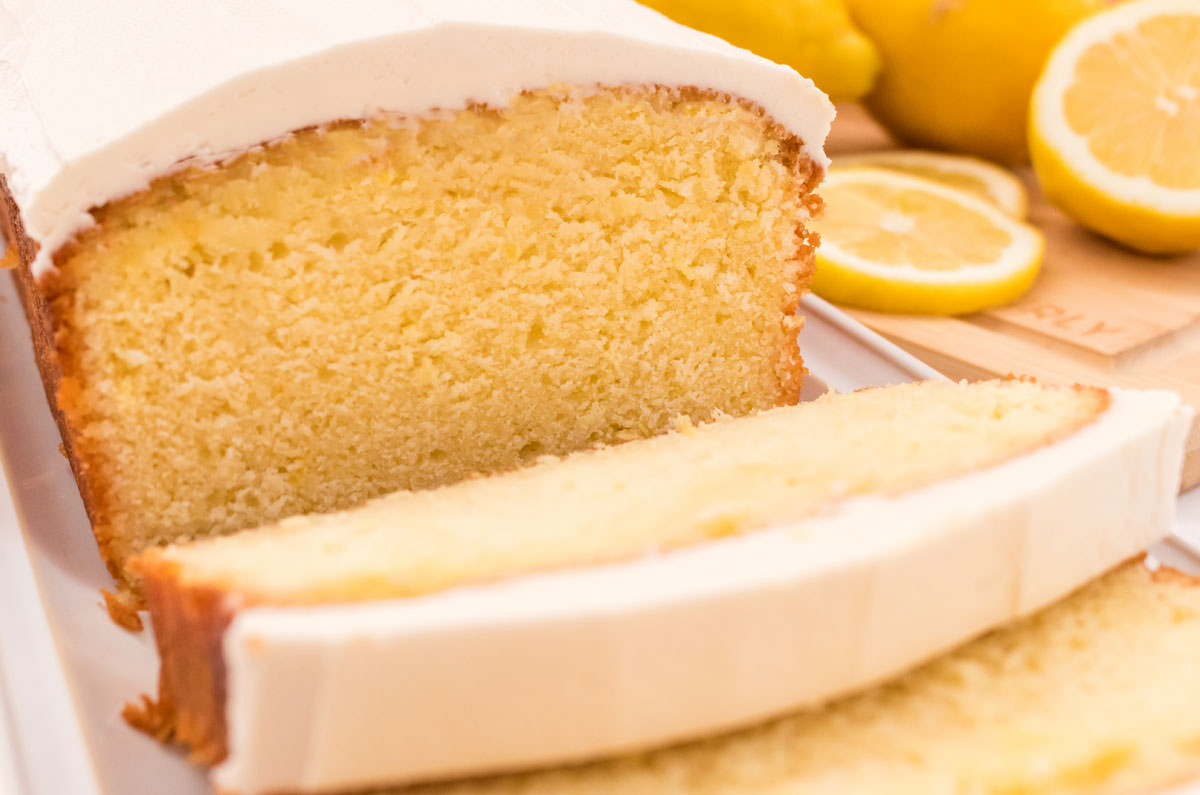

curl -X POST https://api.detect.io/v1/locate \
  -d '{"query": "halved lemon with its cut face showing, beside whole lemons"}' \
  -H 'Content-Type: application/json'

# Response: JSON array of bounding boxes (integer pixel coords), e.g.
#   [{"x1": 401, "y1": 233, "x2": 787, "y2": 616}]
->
[{"x1": 1030, "y1": 0, "x2": 1200, "y2": 253}]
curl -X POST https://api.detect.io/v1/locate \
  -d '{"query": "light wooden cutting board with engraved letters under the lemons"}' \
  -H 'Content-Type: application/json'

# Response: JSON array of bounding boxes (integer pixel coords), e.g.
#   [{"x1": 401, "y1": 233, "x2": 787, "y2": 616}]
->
[{"x1": 828, "y1": 106, "x2": 1200, "y2": 489}]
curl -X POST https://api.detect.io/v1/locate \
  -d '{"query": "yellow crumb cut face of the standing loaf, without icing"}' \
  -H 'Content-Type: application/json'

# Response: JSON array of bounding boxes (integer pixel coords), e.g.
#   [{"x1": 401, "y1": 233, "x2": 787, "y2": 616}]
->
[{"x1": 42, "y1": 88, "x2": 820, "y2": 573}]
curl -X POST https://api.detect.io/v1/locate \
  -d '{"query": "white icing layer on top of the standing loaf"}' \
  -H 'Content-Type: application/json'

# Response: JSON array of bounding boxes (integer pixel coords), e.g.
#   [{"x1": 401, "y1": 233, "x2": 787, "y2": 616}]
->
[{"x1": 0, "y1": 0, "x2": 834, "y2": 273}]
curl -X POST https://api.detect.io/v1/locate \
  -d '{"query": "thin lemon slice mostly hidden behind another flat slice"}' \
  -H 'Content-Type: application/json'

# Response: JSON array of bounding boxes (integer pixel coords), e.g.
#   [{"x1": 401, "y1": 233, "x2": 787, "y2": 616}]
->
[{"x1": 833, "y1": 149, "x2": 1030, "y2": 219}]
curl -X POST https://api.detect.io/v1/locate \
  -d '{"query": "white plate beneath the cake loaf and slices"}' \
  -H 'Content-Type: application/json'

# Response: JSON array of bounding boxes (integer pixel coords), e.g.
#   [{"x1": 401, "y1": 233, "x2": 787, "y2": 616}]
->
[{"x1": 0, "y1": 277, "x2": 1200, "y2": 795}]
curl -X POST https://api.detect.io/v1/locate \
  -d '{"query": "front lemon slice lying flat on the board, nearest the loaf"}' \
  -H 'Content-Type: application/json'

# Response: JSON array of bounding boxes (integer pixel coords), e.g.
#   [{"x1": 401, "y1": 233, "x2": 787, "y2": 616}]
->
[{"x1": 812, "y1": 168, "x2": 1044, "y2": 315}]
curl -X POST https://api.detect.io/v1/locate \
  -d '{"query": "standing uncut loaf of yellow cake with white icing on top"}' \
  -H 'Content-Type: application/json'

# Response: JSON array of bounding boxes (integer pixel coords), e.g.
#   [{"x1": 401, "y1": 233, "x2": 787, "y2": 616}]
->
[{"x1": 0, "y1": 0, "x2": 833, "y2": 590}]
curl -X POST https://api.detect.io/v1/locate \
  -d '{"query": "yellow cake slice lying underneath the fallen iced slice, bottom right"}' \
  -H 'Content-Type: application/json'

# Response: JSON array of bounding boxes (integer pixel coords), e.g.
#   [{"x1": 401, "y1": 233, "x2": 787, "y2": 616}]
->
[{"x1": 403, "y1": 561, "x2": 1200, "y2": 795}]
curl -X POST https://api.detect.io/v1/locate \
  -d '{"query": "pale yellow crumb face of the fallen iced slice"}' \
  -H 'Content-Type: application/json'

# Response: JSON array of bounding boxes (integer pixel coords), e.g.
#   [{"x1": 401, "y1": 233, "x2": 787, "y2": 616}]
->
[{"x1": 136, "y1": 381, "x2": 1108, "y2": 604}]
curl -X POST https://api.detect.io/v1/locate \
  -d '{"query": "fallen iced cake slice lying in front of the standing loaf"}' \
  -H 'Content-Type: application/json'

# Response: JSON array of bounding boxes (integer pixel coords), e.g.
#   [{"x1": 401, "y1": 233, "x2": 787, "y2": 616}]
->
[{"x1": 131, "y1": 381, "x2": 1189, "y2": 793}]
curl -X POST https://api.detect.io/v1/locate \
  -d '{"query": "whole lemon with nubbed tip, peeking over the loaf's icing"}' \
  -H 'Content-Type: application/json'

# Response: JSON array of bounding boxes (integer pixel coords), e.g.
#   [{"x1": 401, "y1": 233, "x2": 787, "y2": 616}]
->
[{"x1": 642, "y1": 0, "x2": 880, "y2": 100}]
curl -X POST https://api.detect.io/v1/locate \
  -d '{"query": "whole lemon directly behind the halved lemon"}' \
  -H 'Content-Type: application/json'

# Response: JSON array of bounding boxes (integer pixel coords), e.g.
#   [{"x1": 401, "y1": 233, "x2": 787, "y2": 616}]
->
[{"x1": 847, "y1": 0, "x2": 1112, "y2": 165}]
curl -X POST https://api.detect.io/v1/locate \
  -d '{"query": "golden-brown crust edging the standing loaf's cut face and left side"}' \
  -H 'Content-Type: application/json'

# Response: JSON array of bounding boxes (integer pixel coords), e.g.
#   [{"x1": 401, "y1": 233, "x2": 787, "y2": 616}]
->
[{"x1": 0, "y1": 84, "x2": 823, "y2": 629}]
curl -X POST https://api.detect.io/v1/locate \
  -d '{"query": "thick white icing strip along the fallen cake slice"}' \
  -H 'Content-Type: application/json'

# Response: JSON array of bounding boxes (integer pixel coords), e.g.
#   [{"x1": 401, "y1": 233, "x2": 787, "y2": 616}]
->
[{"x1": 214, "y1": 390, "x2": 1190, "y2": 795}]
